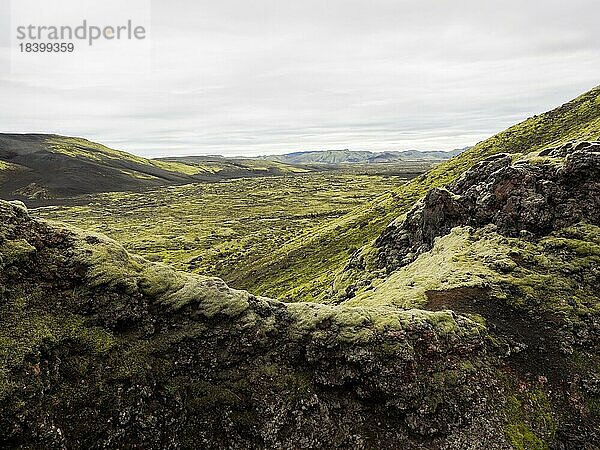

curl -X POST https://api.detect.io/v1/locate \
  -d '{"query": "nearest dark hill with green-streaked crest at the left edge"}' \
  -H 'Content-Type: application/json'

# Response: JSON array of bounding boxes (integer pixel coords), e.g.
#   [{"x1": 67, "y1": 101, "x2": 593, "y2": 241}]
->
[{"x1": 0, "y1": 134, "x2": 197, "y2": 199}]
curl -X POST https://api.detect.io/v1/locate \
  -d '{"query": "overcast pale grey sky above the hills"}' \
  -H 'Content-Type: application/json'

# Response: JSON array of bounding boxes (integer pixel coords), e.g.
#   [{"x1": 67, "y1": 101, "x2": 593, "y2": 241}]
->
[{"x1": 0, "y1": 0, "x2": 600, "y2": 157}]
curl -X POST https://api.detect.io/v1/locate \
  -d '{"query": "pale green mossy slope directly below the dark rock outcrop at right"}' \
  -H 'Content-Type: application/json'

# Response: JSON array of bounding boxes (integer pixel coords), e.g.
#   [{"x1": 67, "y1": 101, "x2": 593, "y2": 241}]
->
[{"x1": 332, "y1": 223, "x2": 600, "y2": 315}]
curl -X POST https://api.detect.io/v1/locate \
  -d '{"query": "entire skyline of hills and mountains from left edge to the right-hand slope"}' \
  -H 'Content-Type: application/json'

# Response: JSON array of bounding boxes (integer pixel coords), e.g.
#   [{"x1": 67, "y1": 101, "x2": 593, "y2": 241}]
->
[{"x1": 0, "y1": 133, "x2": 462, "y2": 204}]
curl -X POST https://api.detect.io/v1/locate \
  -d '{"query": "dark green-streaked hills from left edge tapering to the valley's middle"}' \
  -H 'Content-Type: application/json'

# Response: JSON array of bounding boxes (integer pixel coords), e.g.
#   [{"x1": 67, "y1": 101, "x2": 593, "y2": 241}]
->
[{"x1": 0, "y1": 134, "x2": 309, "y2": 204}]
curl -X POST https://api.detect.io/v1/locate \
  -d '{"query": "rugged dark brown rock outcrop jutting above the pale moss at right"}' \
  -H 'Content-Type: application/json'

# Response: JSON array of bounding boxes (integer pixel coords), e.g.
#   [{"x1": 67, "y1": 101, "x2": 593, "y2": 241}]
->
[{"x1": 376, "y1": 142, "x2": 600, "y2": 272}]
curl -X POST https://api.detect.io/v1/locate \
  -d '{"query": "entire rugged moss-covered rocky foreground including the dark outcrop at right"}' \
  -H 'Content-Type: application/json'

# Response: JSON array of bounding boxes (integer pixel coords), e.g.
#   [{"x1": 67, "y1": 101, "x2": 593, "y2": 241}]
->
[{"x1": 0, "y1": 143, "x2": 600, "y2": 450}]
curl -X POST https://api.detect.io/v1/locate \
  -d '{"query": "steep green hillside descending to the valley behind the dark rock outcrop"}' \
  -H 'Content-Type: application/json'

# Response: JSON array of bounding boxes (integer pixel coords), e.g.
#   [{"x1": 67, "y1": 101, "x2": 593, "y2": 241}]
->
[{"x1": 230, "y1": 87, "x2": 600, "y2": 301}]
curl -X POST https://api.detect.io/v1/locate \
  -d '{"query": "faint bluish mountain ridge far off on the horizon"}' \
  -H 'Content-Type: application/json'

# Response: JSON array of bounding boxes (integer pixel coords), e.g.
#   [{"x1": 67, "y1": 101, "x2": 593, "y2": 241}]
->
[{"x1": 254, "y1": 147, "x2": 470, "y2": 164}]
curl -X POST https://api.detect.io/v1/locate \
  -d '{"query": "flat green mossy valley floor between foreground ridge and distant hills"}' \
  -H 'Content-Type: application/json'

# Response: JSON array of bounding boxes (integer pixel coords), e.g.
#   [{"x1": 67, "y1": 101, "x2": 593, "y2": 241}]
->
[{"x1": 35, "y1": 173, "x2": 406, "y2": 294}]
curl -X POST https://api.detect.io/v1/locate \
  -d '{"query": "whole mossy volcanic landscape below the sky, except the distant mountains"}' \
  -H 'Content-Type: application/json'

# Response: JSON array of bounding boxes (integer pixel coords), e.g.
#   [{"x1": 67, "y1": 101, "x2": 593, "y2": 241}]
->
[{"x1": 0, "y1": 88, "x2": 600, "y2": 450}]
